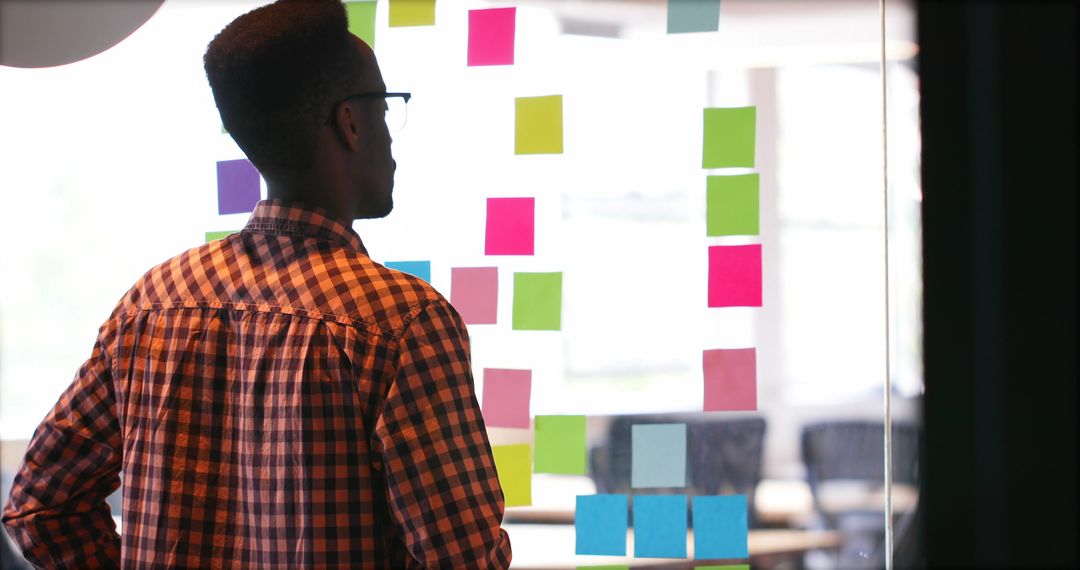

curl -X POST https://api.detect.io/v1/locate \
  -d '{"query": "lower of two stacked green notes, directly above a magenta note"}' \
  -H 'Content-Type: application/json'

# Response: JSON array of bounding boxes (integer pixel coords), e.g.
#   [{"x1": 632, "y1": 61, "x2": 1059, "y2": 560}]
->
[{"x1": 705, "y1": 173, "x2": 760, "y2": 236}]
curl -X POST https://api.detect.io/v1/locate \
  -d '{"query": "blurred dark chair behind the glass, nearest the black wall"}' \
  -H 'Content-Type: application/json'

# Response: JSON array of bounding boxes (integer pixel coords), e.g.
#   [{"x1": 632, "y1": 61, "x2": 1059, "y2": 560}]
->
[{"x1": 800, "y1": 421, "x2": 920, "y2": 568}]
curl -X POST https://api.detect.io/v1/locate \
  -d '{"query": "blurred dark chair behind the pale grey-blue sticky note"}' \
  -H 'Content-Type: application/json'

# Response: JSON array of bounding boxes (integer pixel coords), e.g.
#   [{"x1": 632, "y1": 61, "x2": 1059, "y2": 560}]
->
[{"x1": 589, "y1": 415, "x2": 765, "y2": 528}]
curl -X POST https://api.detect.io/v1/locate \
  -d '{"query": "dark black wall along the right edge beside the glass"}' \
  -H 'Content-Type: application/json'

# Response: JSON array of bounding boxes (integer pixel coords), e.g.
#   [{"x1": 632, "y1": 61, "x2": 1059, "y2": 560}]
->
[{"x1": 918, "y1": 1, "x2": 1080, "y2": 568}]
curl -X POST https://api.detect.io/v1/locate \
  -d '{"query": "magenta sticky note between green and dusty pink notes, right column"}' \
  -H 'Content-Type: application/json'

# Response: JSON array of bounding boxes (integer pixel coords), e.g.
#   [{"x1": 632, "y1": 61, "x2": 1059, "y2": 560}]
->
[{"x1": 708, "y1": 244, "x2": 761, "y2": 307}]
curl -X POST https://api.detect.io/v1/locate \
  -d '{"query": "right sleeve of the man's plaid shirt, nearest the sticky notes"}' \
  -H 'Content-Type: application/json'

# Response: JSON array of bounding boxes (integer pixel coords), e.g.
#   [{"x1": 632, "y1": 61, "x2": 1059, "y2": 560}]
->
[{"x1": 375, "y1": 299, "x2": 511, "y2": 568}]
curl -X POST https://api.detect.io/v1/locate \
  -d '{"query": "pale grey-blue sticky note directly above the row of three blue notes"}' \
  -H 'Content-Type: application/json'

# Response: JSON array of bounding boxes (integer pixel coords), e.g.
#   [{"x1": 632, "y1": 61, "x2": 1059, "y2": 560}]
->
[{"x1": 630, "y1": 423, "x2": 686, "y2": 488}]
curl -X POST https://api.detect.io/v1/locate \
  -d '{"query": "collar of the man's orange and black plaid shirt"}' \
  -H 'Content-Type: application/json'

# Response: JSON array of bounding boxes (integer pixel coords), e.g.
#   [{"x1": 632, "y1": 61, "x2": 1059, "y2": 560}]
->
[{"x1": 244, "y1": 199, "x2": 367, "y2": 256}]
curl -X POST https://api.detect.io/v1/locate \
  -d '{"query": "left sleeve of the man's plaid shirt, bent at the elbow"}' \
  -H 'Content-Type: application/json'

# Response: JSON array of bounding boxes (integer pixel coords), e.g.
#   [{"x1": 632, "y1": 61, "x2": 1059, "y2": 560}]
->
[{"x1": 3, "y1": 318, "x2": 122, "y2": 568}]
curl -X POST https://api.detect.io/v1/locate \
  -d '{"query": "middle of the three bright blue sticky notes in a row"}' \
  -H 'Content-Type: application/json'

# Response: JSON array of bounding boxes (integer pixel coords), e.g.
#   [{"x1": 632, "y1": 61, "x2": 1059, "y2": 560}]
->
[{"x1": 634, "y1": 494, "x2": 687, "y2": 558}]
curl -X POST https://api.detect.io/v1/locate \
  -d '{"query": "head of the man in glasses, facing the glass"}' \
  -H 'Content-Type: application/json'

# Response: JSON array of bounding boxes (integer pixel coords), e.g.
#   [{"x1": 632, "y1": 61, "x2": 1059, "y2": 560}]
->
[{"x1": 203, "y1": 0, "x2": 394, "y2": 218}]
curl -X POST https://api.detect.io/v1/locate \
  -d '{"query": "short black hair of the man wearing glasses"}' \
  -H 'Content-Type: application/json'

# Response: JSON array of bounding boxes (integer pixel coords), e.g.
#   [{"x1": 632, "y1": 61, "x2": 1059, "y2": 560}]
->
[{"x1": 203, "y1": 0, "x2": 363, "y2": 176}]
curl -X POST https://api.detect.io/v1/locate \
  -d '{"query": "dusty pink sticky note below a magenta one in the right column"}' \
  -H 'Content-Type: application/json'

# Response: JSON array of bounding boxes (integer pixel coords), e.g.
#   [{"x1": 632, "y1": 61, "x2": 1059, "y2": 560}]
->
[{"x1": 702, "y1": 349, "x2": 757, "y2": 411}]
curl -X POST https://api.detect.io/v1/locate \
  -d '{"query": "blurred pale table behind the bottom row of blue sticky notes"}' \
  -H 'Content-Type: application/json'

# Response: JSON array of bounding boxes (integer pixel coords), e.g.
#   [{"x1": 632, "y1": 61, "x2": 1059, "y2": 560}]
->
[{"x1": 503, "y1": 524, "x2": 843, "y2": 570}]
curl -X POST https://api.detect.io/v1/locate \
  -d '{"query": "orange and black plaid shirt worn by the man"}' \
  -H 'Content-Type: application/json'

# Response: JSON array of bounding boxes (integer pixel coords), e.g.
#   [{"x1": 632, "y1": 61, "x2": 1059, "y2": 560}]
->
[{"x1": 3, "y1": 201, "x2": 511, "y2": 568}]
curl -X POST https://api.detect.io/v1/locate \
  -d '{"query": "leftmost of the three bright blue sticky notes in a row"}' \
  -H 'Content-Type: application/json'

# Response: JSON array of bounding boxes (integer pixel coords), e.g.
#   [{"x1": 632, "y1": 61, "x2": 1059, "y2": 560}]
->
[{"x1": 573, "y1": 494, "x2": 627, "y2": 556}]
